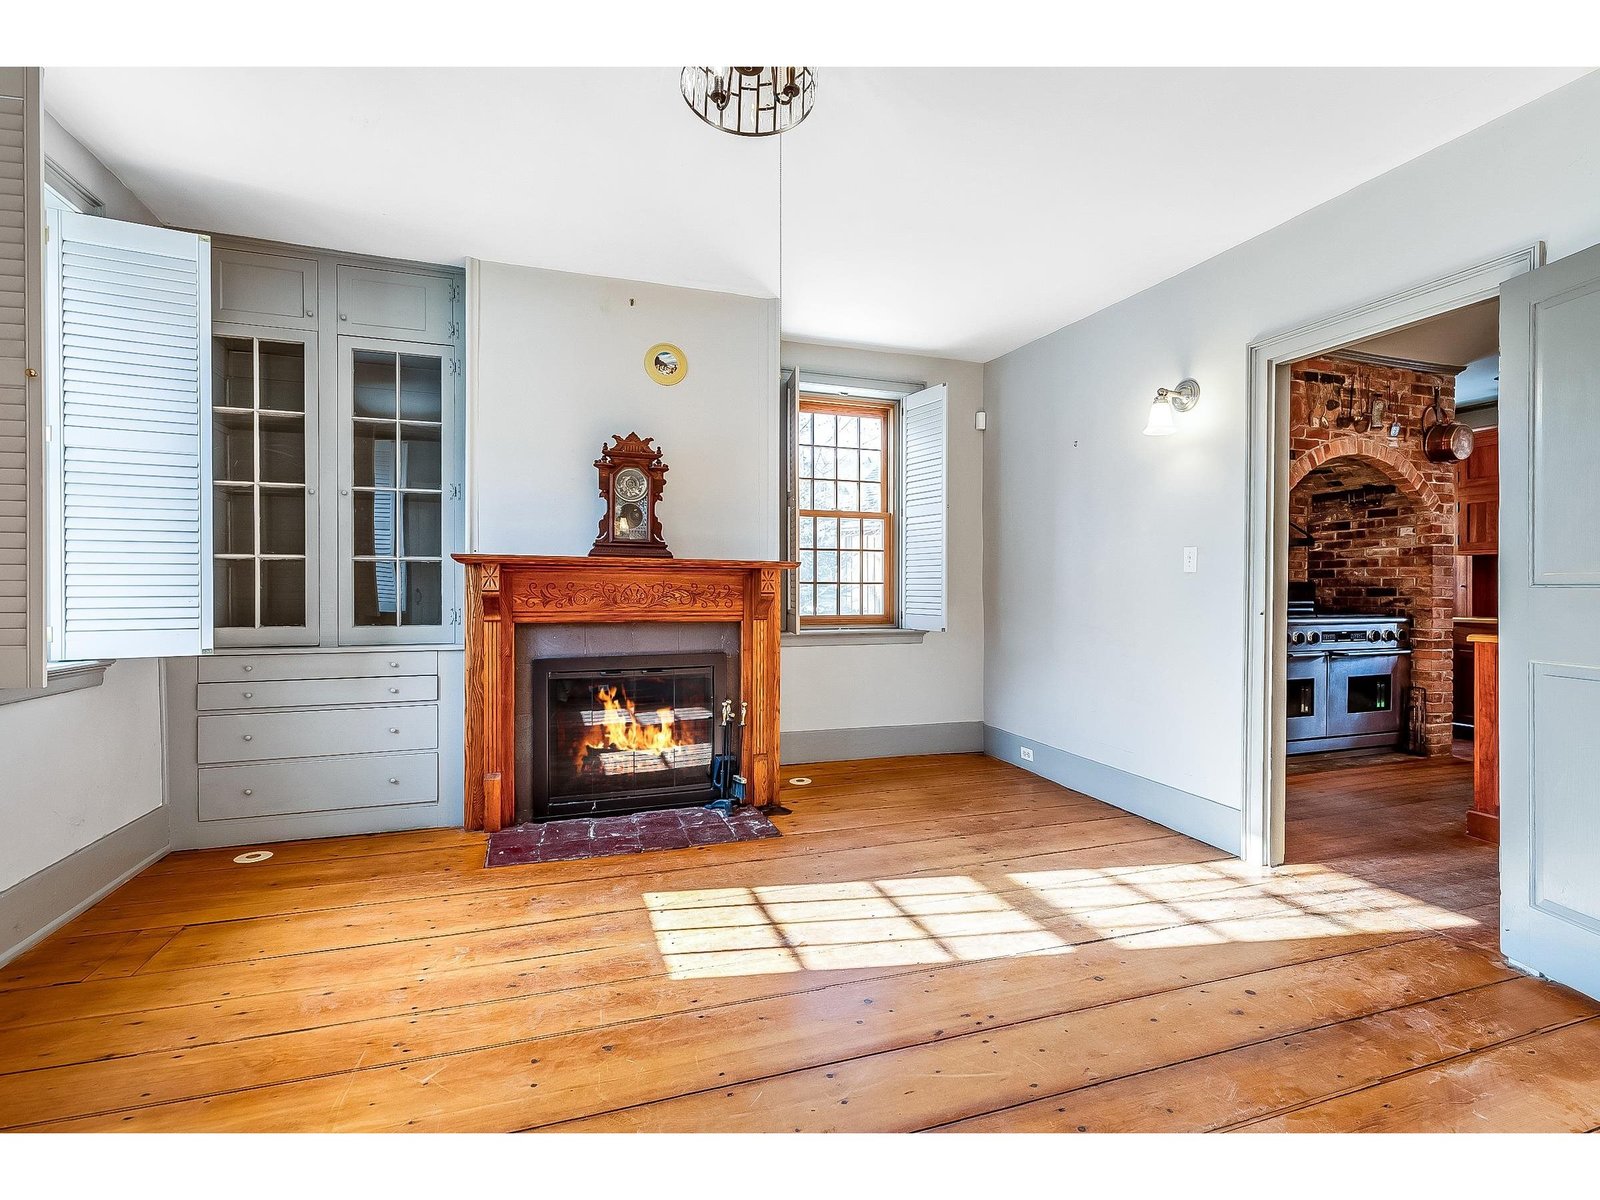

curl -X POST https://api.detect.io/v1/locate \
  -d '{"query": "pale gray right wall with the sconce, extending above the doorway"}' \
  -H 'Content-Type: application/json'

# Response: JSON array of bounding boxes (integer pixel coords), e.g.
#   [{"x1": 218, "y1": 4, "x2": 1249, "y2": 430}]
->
[{"x1": 984, "y1": 75, "x2": 1600, "y2": 844}]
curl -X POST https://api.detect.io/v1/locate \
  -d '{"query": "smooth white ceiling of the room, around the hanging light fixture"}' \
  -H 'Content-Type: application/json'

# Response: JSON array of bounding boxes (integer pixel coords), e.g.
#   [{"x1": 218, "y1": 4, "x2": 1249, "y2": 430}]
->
[{"x1": 45, "y1": 67, "x2": 1582, "y2": 362}]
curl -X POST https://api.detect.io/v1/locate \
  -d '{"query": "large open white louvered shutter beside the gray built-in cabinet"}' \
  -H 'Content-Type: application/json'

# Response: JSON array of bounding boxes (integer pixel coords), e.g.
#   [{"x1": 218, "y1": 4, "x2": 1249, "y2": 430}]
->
[{"x1": 46, "y1": 213, "x2": 211, "y2": 661}]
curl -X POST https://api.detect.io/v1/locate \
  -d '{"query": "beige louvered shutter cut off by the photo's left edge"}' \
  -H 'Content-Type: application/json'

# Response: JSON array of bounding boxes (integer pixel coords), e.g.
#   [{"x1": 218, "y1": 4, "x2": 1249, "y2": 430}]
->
[{"x1": 0, "y1": 67, "x2": 45, "y2": 688}]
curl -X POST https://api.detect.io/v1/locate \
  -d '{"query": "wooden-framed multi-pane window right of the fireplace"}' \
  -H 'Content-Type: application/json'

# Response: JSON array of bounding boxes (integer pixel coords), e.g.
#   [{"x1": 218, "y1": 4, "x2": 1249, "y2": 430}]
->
[{"x1": 795, "y1": 404, "x2": 896, "y2": 626}]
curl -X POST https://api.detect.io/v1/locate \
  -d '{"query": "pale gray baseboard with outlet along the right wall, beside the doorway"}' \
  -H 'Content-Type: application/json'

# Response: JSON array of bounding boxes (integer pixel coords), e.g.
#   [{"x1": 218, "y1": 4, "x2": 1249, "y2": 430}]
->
[{"x1": 984, "y1": 725, "x2": 1245, "y2": 854}]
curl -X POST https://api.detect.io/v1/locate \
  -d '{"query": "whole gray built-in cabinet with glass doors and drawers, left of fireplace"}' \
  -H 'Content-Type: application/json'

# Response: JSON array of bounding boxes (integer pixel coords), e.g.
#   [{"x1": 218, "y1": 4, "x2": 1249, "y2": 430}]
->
[{"x1": 166, "y1": 240, "x2": 464, "y2": 846}]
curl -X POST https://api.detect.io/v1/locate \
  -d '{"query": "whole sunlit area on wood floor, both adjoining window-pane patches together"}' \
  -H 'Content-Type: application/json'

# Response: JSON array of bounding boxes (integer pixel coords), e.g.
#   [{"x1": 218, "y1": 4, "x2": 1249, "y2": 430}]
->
[{"x1": 643, "y1": 861, "x2": 1478, "y2": 979}]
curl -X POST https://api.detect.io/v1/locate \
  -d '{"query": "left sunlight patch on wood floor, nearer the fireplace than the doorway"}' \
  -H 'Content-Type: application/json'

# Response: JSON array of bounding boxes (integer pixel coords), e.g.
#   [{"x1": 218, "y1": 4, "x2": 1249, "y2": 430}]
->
[{"x1": 645, "y1": 875, "x2": 1070, "y2": 979}]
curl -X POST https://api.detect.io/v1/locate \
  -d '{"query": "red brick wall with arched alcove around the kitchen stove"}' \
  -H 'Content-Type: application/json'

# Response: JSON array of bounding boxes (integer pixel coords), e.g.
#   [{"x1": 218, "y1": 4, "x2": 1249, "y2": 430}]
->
[{"x1": 1290, "y1": 358, "x2": 1456, "y2": 754}]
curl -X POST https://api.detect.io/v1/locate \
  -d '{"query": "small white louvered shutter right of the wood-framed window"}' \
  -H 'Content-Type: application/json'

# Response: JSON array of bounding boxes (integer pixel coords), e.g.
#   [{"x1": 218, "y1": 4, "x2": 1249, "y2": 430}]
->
[{"x1": 901, "y1": 384, "x2": 949, "y2": 630}]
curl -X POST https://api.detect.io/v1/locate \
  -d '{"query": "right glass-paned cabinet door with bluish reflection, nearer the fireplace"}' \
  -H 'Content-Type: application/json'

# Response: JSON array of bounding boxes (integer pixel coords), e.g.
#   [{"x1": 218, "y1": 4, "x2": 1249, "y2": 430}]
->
[{"x1": 339, "y1": 338, "x2": 456, "y2": 643}]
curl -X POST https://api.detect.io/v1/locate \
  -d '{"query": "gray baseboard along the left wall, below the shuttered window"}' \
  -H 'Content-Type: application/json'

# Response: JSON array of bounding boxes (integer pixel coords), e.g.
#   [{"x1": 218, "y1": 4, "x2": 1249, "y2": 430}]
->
[{"x1": 0, "y1": 808, "x2": 171, "y2": 965}]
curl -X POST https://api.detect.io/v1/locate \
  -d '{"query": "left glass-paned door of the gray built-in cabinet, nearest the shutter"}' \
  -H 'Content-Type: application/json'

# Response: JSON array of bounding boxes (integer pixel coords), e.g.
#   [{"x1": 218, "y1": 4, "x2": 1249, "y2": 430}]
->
[{"x1": 211, "y1": 325, "x2": 317, "y2": 646}]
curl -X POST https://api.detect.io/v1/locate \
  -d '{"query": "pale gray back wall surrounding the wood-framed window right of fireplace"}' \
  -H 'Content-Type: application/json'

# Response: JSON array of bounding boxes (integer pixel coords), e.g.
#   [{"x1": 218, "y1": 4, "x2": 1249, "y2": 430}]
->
[{"x1": 782, "y1": 342, "x2": 984, "y2": 733}]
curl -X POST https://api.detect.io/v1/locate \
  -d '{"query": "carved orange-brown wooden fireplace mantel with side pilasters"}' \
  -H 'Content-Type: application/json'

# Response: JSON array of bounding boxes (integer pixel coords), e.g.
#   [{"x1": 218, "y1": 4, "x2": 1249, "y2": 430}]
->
[{"x1": 454, "y1": 554, "x2": 798, "y2": 832}]
